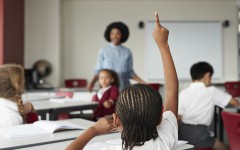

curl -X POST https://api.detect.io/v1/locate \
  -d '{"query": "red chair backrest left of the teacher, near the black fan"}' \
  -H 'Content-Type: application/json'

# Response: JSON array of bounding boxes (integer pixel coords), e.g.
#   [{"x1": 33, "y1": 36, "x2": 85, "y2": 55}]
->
[{"x1": 65, "y1": 79, "x2": 87, "y2": 88}]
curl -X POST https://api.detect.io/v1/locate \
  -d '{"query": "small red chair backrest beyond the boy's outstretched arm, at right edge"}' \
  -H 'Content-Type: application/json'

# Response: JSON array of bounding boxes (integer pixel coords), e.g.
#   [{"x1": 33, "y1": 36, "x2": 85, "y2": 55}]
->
[{"x1": 224, "y1": 81, "x2": 240, "y2": 97}]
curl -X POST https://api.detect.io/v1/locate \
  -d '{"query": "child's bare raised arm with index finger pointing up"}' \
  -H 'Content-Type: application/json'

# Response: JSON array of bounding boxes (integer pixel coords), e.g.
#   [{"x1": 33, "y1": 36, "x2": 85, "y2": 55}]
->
[{"x1": 153, "y1": 13, "x2": 178, "y2": 117}]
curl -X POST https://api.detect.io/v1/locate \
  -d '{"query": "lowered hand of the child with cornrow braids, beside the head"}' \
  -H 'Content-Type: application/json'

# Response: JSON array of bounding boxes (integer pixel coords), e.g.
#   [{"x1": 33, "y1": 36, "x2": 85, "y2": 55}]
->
[{"x1": 91, "y1": 116, "x2": 116, "y2": 135}]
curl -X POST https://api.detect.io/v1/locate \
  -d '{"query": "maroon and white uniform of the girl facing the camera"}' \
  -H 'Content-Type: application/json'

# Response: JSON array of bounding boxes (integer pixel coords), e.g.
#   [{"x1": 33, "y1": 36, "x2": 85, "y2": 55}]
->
[{"x1": 93, "y1": 86, "x2": 119, "y2": 120}]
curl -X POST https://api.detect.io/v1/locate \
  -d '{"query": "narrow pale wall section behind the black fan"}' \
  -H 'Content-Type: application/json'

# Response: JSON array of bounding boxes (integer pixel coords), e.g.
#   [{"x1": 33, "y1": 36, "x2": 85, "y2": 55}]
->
[{"x1": 24, "y1": 0, "x2": 61, "y2": 87}]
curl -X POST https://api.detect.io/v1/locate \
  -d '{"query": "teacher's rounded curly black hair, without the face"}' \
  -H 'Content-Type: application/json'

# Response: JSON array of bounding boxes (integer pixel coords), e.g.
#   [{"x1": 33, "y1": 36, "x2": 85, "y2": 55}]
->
[{"x1": 104, "y1": 22, "x2": 129, "y2": 43}]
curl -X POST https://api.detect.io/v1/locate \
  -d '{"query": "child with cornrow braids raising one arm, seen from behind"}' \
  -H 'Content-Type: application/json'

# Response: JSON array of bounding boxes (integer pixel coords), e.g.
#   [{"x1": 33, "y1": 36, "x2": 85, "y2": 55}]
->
[{"x1": 67, "y1": 13, "x2": 178, "y2": 150}]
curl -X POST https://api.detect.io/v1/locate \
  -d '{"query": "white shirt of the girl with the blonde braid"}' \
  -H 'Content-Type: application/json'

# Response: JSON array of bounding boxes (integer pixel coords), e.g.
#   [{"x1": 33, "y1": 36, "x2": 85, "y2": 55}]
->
[{"x1": 0, "y1": 98, "x2": 23, "y2": 127}]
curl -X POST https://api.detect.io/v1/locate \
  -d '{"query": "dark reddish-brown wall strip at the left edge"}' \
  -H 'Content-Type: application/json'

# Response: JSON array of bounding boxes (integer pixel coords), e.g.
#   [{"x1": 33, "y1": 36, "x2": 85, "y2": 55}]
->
[{"x1": 0, "y1": 0, "x2": 24, "y2": 65}]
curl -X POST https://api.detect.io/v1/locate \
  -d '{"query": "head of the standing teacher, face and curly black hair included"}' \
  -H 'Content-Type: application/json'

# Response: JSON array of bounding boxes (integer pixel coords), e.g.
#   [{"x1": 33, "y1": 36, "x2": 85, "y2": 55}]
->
[{"x1": 104, "y1": 22, "x2": 129, "y2": 45}]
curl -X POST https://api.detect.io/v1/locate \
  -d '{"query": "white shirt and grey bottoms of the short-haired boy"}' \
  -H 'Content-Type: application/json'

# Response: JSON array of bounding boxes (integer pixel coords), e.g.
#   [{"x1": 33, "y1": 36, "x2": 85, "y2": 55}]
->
[{"x1": 178, "y1": 82, "x2": 232, "y2": 148}]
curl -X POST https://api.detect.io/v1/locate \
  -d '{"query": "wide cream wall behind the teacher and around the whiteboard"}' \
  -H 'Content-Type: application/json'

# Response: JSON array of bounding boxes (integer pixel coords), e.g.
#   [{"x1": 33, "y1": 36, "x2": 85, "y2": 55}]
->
[{"x1": 61, "y1": 0, "x2": 238, "y2": 85}]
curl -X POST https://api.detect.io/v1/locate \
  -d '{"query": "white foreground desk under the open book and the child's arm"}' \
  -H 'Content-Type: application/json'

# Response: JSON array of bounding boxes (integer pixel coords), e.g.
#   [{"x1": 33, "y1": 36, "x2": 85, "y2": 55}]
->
[{"x1": 0, "y1": 119, "x2": 193, "y2": 150}]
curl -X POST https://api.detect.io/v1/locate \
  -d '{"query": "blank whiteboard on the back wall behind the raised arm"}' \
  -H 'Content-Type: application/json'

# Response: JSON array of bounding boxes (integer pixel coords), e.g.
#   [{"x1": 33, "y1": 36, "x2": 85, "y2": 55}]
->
[{"x1": 145, "y1": 21, "x2": 223, "y2": 81}]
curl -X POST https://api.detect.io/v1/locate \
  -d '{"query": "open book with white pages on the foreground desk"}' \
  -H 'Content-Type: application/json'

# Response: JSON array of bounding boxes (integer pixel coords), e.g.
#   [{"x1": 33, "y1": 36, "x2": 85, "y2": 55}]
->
[{"x1": 0, "y1": 120, "x2": 86, "y2": 139}]
